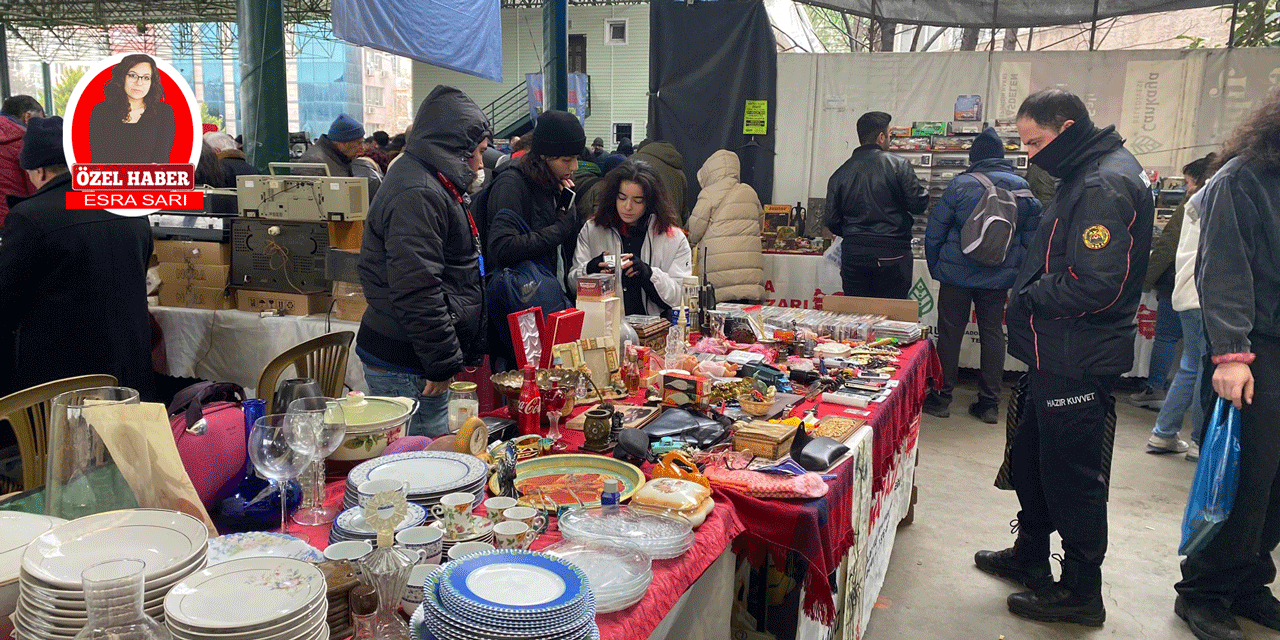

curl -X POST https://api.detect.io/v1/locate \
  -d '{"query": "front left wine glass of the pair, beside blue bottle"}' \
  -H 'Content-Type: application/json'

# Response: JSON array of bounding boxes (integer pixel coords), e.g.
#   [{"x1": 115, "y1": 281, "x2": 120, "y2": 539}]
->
[{"x1": 248, "y1": 413, "x2": 316, "y2": 534}]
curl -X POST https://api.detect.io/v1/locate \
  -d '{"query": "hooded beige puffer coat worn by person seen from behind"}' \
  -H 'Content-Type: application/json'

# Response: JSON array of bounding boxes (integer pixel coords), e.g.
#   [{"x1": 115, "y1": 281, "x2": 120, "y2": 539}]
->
[{"x1": 689, "y1": 148, "x2": 764, "y2": 301}]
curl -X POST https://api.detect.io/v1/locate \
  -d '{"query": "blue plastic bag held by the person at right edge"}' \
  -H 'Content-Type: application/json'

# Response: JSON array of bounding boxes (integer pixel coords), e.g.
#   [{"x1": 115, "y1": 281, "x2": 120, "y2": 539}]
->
[{"x1": 1178, "y1": 398, "x2": 1240, "y2": 556}]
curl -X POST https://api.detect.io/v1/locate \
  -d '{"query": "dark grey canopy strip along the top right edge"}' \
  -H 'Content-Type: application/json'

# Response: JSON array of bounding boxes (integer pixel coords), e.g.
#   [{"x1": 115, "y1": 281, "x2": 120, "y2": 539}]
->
[{"x1": 796, "y1": 0, "x2": 1229, "y2": 28}]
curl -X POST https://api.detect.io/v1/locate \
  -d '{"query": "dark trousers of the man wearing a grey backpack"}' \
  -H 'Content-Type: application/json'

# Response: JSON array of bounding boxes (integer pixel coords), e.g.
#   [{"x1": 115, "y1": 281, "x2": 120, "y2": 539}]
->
[{"x1": 938, "y1": 283, "x2": 1009, "y2": 408}]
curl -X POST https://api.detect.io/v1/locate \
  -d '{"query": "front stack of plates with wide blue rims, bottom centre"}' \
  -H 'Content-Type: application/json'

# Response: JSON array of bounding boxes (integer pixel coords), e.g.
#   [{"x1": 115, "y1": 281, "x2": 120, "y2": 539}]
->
[{"x1": 413, "y1": 549, "x2": 600, "y2": 640}]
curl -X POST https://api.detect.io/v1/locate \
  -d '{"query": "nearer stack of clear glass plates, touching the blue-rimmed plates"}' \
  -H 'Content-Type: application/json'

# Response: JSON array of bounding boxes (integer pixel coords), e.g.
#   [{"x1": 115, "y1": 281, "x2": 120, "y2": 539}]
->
[{"x1": 543, "y1": 540, "x2": 653, "y2": 613}]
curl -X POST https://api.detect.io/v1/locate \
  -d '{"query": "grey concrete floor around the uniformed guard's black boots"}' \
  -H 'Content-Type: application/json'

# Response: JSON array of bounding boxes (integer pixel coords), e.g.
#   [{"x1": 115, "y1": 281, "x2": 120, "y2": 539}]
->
[{"x1": 865, "y1": 384, "x2": 1280, "y2": 640}]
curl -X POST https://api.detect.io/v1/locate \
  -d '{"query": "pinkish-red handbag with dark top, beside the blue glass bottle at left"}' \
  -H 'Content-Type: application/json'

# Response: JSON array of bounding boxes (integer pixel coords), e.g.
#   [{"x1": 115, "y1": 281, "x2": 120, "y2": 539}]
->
[{"x1": 169, "y1": 381, "x2": 248, "y2": 508}]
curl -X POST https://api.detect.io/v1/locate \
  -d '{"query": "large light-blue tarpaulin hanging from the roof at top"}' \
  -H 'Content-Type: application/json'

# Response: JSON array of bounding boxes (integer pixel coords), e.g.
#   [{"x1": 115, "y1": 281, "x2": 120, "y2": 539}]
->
[{"x1": 333, "y1": 0, "x2": 502, "y2": 82}]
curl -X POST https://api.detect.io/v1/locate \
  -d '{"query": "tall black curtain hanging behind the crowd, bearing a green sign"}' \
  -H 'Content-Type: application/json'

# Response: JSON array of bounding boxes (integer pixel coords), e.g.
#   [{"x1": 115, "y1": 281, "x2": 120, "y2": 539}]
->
[{"x1": 648, "y1": 0, "x2": 778, "y2": 202}]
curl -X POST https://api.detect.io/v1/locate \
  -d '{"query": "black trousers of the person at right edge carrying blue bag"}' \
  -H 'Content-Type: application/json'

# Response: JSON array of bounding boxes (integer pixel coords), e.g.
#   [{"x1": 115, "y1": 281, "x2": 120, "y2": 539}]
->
[{"x1": 1176, "y1": 334, "x2": 1280, "y2": 603}]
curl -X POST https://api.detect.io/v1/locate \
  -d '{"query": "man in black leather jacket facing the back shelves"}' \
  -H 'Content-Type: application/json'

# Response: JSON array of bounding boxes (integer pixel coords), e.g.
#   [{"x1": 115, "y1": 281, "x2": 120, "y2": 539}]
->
[{"x1": 823, "y1": 111, "x2": 929, "y2": 300}]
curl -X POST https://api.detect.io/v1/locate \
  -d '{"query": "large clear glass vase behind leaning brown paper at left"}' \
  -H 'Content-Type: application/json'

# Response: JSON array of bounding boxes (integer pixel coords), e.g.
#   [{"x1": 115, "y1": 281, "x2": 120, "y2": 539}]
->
[{"x1": 45, "y1": 387, "x2": 138, "y2": 520}]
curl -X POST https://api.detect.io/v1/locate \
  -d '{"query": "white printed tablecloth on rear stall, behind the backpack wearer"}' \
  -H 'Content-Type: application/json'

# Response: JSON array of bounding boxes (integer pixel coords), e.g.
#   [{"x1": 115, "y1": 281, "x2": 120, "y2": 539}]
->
[{"x1": 764, "y1": 253, "x2": 1156, "y2": 378}]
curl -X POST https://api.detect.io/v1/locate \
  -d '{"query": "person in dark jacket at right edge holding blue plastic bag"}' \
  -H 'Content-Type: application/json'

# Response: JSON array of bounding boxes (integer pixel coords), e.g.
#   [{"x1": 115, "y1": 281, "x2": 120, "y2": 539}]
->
[{"x1": 1174, "y1": 91, "x2": 1280, "y2": 640}]
